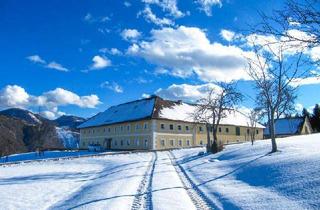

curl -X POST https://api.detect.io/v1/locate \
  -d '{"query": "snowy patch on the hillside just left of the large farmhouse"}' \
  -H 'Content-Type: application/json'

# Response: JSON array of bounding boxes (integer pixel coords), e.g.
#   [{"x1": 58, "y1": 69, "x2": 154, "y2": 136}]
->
[{"x1": 56, "y1": 127, "x2": 80, "y2": 149}]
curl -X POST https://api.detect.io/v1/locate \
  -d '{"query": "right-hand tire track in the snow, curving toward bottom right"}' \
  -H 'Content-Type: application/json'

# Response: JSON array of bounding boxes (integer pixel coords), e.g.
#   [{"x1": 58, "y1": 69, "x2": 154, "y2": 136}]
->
[{"x1": 169, "y1": 151, "x2": 219, "y2": 210}]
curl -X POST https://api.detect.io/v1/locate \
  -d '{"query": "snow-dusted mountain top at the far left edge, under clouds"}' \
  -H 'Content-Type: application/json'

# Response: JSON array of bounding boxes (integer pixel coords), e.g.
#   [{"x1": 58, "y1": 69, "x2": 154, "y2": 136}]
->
[{"x1": 0, "y1": 108, "x2": 49, "y2": 125}]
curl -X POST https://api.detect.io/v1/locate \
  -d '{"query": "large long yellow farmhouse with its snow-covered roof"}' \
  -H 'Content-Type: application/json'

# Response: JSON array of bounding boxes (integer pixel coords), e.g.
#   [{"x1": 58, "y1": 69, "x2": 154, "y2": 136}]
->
[{"x1": 79, "y1": 96, "x2": 264, "y2": 150}]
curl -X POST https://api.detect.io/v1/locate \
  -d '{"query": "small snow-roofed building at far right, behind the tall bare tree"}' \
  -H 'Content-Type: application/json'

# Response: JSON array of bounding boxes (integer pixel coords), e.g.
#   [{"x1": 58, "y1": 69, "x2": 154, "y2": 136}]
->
[{"x1": 264, "y1": 117, "x2": 312, "y2": 138}]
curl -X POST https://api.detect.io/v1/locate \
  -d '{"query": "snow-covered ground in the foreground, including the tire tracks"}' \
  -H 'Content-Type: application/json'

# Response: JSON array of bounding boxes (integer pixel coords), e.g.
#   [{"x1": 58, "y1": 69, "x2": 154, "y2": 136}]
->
[{"x1": 0, "y1": 134, "x2": 320, "y2": 210}]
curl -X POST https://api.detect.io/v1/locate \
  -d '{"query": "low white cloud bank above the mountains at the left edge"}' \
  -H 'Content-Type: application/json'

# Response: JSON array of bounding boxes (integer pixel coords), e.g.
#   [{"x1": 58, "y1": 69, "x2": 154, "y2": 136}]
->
[{"x1": 0, "y1": 85, "x2": 101, "y2": 119}]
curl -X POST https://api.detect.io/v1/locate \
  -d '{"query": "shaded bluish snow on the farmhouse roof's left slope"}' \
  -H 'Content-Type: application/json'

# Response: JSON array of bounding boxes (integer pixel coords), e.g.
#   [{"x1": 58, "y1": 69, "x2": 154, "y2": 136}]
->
[{"x1": 78, "y1": 98, "x2": 155, "y2": 128}]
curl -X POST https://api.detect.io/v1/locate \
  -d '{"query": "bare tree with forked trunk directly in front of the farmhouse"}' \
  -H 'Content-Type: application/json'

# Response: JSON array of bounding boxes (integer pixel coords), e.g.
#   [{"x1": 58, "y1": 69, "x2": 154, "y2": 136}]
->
[{"x1": 194, "y1": 82, "x2": 243, "y2": 153}]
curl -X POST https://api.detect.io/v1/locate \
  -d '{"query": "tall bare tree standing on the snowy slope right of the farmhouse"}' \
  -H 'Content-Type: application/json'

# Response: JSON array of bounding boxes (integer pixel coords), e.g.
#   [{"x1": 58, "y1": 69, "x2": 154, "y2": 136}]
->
[{"x1": 247, "y1": 37, "x2": 308, "y2": 152}]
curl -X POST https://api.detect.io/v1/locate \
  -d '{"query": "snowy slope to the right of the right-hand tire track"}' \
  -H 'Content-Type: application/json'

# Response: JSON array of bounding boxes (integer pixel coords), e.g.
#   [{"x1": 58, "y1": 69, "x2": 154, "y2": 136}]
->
[{"x1": 175, "y1": 134, "x2": 320, "y2": 209}]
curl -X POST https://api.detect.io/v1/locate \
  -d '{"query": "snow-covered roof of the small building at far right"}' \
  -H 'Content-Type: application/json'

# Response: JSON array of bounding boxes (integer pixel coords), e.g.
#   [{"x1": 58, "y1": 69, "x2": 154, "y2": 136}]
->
[{"x1": 264, "y1": 117, "x2": 304, "y2": 135}]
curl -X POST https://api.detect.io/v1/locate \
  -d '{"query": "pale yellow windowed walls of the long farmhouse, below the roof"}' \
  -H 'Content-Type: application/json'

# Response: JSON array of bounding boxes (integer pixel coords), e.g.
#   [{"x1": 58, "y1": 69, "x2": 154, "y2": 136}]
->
[{"x1": 80, "y1": 119, "x2": 263, "y2": 150}]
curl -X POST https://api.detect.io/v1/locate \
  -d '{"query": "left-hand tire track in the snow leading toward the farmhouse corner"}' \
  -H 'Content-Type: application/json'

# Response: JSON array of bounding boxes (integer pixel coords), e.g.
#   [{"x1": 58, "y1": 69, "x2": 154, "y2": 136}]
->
[{"x1": 131, "y1": 152, "x2": 158, "y2": 210}]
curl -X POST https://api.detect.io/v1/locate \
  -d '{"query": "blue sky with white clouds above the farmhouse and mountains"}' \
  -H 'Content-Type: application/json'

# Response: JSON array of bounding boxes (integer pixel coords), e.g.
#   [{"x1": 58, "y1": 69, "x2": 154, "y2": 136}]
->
[{"x1": 0, "y1": 0, "x2": 320, "y2": 118}]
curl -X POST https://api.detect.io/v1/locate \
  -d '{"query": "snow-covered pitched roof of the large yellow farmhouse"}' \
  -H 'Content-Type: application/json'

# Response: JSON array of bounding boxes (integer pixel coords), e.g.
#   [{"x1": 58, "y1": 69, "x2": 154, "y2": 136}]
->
[{"x1": 79, "y1": 96, "x2": 264, "y2": 128}]
